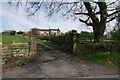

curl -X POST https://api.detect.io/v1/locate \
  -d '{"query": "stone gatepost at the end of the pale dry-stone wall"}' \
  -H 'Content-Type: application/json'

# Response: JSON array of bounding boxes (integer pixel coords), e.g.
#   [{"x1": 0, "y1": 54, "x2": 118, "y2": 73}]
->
[{"x1": 28, "y1": 36, "x2": 37, "y2": 57}]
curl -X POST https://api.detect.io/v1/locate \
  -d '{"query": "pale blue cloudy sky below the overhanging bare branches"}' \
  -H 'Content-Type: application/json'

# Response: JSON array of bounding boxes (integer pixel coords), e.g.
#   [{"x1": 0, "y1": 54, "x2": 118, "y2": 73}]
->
[{"x1": 0, "y1": 2, "x2": 92, "y2": 32}]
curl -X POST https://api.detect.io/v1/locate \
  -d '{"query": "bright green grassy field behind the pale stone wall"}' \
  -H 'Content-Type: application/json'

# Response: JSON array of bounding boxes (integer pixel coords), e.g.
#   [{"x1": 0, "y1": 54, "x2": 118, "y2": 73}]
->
[{"x1": 2, "y1": 34, "x2": 28, "y2": 44}]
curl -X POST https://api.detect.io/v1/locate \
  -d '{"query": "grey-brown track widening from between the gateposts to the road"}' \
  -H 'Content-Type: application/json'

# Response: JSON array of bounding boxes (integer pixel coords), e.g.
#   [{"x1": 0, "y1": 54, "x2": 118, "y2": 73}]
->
[{"x1": 2, "y1": 44, "x2": 118, "y2": 78}]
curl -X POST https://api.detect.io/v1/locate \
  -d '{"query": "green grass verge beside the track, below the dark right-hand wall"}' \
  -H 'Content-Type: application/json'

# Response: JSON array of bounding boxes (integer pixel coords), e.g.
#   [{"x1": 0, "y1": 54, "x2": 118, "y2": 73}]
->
[{"x1": 74, "y1": 52, "x2": 120, "y2": 67}]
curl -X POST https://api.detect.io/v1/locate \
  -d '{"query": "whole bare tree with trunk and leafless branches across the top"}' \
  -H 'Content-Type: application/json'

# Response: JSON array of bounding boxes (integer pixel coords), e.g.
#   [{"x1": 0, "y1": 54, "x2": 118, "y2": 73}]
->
[{"x1": 8, "y1": 0, "x2": 120, "y2": 43}]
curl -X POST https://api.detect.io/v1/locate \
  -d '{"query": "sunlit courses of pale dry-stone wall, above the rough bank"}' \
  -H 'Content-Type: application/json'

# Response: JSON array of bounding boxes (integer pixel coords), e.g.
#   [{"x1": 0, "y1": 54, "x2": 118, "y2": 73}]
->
[{"x1": 2, "y1": 44, "x2": 29, "y2": 56}]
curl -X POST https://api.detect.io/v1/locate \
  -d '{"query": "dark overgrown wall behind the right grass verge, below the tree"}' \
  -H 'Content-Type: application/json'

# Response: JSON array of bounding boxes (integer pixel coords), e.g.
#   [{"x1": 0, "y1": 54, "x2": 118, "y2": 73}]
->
[{"x1": 76, "y1": 42, "x2": 120, "y2": 54}]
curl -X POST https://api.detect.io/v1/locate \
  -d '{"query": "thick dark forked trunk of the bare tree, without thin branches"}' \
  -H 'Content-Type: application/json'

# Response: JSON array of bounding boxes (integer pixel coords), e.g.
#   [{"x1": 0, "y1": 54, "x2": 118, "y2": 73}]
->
[{"x1": 84, "y1": 2, "x2": 108, "y2": 43}]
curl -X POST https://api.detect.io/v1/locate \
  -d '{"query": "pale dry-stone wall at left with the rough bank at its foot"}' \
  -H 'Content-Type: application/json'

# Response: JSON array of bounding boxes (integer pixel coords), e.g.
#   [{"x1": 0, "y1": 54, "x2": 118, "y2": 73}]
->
[{"x1": 2, "y1": 44, "x2": 30, "y2": 68}]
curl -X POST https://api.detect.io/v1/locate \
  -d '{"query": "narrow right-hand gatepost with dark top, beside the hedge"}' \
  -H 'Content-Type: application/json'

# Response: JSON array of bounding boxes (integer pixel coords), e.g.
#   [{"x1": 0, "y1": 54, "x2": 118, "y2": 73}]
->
[{"x1": 70, "y1": 30, "x2": 78, "y2": 53}]
